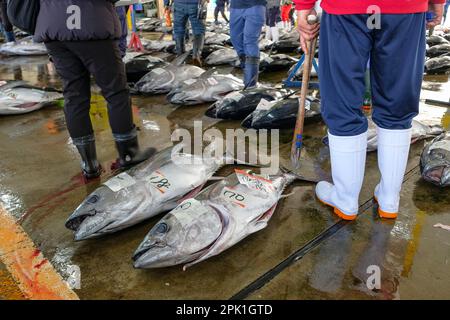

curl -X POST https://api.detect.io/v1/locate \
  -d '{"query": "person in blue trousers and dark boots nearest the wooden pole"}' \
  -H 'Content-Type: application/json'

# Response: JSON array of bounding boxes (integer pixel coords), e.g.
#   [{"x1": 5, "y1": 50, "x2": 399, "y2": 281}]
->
[{"x1": 230, "y1": 0, "x2": 267, "y2": 88}]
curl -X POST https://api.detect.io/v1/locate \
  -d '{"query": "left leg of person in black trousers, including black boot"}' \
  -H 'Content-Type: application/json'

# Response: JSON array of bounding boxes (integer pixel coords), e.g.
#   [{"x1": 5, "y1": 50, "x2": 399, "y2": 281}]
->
[{"x1": 46, "y1": 41, "x2": 100, "y2": 178}]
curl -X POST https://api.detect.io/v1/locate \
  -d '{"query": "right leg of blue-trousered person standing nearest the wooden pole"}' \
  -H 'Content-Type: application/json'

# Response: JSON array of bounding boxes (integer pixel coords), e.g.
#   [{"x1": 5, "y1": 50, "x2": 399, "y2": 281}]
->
[{"x1": 244, "y1": 6, "x2": 266, "y2": 88}]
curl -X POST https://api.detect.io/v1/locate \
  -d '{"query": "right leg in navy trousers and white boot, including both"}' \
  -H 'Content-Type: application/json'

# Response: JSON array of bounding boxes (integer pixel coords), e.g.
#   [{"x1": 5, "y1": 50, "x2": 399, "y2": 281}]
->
[{"x1": 370, "y1": 13, "x2": 426, "y2": 218}]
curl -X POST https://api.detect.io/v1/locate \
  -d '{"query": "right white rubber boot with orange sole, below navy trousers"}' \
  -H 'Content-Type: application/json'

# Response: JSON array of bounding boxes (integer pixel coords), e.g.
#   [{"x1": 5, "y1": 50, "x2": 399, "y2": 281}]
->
[{"x1": 375, "y1": 127, "x2": 411, "y2": 219}]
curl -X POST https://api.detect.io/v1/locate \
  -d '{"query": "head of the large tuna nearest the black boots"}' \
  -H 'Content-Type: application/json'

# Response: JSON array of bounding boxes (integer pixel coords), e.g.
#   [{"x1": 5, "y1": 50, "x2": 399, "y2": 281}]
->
[{"x1": 66, "y1": 183, "x2": 152, "y2": 241}]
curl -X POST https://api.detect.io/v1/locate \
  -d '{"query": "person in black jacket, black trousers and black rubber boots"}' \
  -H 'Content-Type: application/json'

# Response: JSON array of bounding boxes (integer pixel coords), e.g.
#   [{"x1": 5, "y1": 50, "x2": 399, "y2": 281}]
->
[{"x1": 34, "y1": 0, "x2": 156, "y2": 179}]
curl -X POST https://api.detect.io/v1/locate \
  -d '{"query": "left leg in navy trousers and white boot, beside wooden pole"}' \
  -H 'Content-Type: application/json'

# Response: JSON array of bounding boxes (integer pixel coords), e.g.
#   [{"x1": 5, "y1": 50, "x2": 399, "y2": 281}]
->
[{"x1": 316, "y1": 12, "x2": 372, "y2": 220}]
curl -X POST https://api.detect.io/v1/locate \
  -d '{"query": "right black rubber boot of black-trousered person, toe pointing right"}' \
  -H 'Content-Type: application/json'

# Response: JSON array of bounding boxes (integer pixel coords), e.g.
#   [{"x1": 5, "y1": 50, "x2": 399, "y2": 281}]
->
[{"x1": 114, "y1": 128, "x2": 156, "y2": 169}]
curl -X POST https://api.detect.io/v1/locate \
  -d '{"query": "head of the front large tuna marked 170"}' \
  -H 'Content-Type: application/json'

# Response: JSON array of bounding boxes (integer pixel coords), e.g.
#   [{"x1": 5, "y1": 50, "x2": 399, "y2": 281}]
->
[{"x1": 133, "y1": 199, "x2": 222, "y2": 268}]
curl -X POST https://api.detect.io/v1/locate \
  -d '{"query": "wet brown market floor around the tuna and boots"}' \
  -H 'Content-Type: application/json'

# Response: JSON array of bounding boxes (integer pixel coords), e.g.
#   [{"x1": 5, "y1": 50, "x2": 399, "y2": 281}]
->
[{"x1": 0, "y1": 52, "x2": 450, "y2": 299}]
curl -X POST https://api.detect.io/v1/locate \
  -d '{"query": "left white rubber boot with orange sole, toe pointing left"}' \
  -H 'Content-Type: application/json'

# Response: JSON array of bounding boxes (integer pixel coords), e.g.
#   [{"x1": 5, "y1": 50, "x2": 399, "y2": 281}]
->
[{"x1": 316, "y1": 132, "x2": 367, "y2": 220}]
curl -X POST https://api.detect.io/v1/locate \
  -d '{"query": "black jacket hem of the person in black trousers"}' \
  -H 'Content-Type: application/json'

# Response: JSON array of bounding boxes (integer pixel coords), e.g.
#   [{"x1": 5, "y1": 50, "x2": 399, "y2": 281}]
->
[{"x1": 34, "y1": 0, "x2": 122, "y2": 42}]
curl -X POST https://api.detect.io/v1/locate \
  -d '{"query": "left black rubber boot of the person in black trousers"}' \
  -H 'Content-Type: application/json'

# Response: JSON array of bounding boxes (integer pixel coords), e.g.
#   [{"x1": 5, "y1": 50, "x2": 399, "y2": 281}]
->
[{"x1": 72, "y1": 135, "x2": 101, "y2": 179}]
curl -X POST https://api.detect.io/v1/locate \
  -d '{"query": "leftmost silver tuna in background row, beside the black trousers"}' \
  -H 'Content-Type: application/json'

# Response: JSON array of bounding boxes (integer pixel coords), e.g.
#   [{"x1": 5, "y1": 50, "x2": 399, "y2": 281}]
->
[{"x1": 134, "y1": 53, "x2": 205, "y2": 94}]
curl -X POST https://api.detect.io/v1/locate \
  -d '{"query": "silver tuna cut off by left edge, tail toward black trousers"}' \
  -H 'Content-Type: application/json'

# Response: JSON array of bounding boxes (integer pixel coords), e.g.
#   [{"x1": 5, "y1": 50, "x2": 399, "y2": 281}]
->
[{"x1": 0, "y1": 81, "x2": 63, "y2": 115}]
